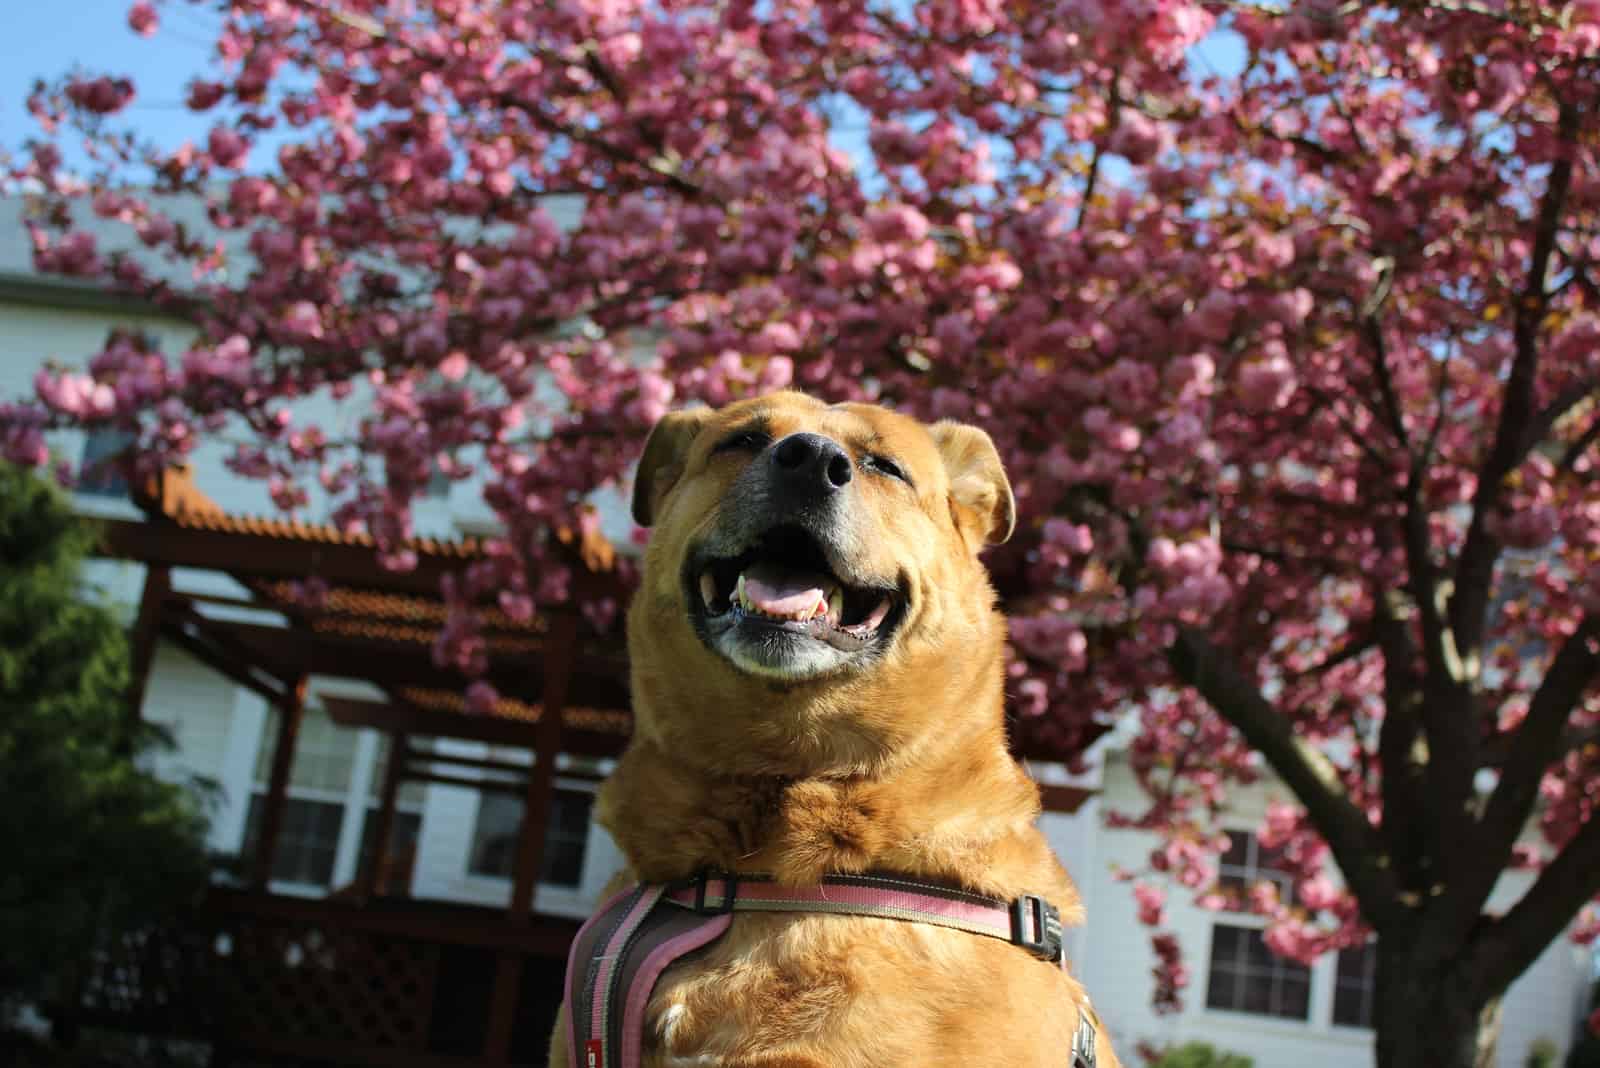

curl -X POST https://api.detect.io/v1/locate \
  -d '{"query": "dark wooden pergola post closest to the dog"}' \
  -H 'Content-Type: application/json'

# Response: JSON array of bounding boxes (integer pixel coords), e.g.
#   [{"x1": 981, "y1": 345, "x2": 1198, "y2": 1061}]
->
[{"x1": 483, "y1": 612, "x2": 578, "y2": 1065}]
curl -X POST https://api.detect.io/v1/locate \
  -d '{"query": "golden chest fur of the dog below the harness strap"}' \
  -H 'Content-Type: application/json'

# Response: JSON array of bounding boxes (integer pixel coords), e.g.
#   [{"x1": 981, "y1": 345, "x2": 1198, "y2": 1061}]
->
[{"x1": 643, "y1": 915, "x2": 1075, "y2": 1068}]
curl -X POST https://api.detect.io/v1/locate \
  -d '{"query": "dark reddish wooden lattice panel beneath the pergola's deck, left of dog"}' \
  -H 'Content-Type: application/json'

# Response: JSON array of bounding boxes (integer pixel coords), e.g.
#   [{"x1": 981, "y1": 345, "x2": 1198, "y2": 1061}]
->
[{"x1": 216, "y1": 919, "x2": 438, "y2": 1050}]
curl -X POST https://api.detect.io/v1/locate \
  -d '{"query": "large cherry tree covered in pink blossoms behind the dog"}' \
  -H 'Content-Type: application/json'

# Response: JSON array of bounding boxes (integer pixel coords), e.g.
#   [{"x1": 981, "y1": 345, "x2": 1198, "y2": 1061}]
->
[{"x1": 0, "y1": 0, "x2": 1600, "y2": 1068}]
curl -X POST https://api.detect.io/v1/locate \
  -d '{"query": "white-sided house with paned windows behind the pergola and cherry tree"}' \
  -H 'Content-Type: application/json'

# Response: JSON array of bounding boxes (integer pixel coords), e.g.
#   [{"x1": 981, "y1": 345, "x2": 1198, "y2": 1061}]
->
[{"x1": 0, "y1": 200, "x2": 1592, "y2": 1068}]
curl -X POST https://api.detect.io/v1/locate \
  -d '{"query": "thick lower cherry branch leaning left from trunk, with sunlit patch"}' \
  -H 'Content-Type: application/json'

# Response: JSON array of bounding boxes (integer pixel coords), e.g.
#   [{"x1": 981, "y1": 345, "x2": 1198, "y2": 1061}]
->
[{"x1": 1166, "y1": 627, "x2": 1402, "y2": 929}]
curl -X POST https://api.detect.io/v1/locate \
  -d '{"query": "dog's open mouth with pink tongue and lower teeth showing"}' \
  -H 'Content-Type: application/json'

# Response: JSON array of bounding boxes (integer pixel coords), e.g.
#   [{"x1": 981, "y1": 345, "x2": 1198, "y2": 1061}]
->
[{"x1": 685, "y1": 526, "x2": 902, "y2": 652}]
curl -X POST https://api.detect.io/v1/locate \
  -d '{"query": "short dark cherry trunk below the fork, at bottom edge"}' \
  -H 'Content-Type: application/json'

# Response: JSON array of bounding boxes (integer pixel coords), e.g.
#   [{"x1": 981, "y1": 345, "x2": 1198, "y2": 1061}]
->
[{"x1": 1373, "y1": 935, "x2": 1501, "y2": 1068}]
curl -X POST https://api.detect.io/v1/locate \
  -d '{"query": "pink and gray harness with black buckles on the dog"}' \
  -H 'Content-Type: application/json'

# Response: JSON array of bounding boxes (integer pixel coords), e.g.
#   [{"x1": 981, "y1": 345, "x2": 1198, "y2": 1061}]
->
[{"x1": 566, "y1": 873, "x2": 1094, "y2": 1068}]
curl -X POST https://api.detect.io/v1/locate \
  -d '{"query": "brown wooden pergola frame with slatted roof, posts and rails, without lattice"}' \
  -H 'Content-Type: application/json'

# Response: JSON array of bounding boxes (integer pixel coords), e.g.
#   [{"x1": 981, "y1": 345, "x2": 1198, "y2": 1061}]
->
[{"x1": 89, "y1": 470, "x2": 632, "y2": 1065}]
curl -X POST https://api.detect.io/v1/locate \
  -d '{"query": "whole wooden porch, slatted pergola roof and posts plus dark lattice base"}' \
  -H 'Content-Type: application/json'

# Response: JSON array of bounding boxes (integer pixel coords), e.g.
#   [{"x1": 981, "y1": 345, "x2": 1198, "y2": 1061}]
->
[{"x1": 62, "y1": 472, "x2": 1107, "y2": 1068}]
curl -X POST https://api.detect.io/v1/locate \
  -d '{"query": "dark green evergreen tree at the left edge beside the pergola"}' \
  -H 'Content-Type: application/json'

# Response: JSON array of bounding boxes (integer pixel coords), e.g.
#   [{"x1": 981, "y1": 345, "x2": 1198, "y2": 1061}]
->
[{"x1": 0, "y1": 465, "x2": 206, "y2": 1007}]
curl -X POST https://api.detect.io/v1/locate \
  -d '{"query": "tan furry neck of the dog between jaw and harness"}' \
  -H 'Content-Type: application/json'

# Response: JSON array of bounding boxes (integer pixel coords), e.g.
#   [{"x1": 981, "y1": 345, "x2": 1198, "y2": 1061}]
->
[{"x1": 600, "y1": 726, "x2": 1040, "y2": 892}]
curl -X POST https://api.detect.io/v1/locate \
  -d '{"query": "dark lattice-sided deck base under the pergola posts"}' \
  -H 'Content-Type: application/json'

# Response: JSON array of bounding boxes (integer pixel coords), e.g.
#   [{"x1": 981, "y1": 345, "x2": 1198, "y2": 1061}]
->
[{"x1": 72, "y1": 891, "x2": 578, "y2": 1068}]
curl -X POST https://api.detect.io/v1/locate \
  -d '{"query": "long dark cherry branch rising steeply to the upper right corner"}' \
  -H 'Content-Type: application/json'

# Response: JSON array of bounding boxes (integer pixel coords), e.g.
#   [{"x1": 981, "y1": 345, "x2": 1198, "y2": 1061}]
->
[{"x1": 1450, "y1": 102, "x2": 1579, "y2": 657}]
